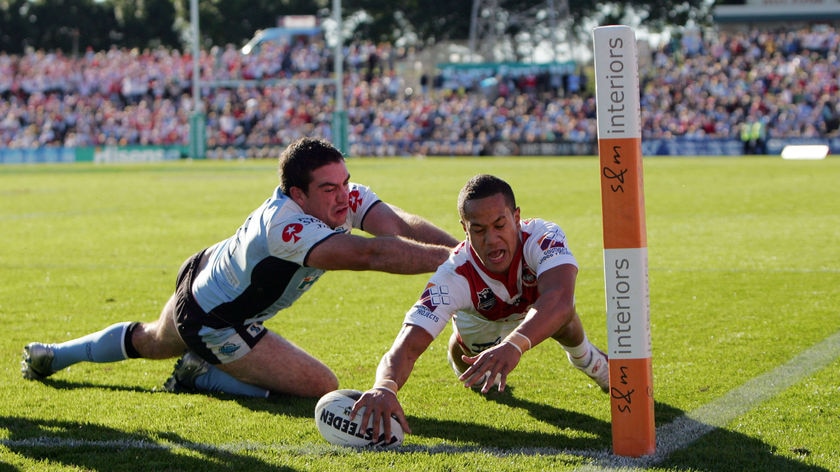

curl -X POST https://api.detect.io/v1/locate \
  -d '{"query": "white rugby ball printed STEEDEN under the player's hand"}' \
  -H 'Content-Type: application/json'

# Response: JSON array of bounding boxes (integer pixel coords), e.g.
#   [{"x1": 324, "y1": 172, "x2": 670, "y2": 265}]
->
[{"x1": 315, "y1": 389, "x2": 405, "y2": 448}]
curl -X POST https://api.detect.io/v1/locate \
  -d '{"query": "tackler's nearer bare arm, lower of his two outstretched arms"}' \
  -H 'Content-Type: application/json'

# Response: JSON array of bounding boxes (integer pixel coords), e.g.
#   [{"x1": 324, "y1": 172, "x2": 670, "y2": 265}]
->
[{"x1": 305, "y1": 233, "x2": 450, "y2": 274}]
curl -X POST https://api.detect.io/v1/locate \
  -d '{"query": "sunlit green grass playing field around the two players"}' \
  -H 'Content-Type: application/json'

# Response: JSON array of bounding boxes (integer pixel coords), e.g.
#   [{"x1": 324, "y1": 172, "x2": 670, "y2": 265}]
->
[{"x1": 0, "y1": 157, "x2": 840, "y2": 472}]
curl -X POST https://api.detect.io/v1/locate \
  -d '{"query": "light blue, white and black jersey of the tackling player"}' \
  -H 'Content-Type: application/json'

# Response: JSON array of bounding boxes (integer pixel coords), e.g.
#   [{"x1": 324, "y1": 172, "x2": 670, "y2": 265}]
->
[{"x1": 192, "y1": 183, "x2": 380, "y2": 324}]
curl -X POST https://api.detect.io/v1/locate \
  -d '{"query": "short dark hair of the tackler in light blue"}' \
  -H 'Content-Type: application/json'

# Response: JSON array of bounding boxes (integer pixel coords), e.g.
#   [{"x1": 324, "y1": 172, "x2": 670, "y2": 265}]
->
[{"x1": 279, "y1": 138, "x2": 344, "y2": 195}]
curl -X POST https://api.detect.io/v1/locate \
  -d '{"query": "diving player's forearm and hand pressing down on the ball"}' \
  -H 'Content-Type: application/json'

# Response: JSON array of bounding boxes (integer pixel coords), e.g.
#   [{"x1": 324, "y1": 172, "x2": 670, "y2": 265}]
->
[{"x1": 351, "y1": 325, "x2": 434, "y2": 437}]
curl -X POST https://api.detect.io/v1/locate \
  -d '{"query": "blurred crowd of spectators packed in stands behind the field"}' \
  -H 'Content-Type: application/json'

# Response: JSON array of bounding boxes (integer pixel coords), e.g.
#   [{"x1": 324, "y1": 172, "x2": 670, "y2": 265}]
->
[{"x1": 0, "y1": 26, "x2": 840, "y2": 155}]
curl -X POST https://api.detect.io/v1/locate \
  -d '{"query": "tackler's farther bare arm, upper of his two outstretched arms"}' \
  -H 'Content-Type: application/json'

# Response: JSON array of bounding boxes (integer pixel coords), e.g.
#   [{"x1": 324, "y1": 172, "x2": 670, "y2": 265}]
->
[{"x1": 362, "y1": 202, "x2": 458, "y2": 247}]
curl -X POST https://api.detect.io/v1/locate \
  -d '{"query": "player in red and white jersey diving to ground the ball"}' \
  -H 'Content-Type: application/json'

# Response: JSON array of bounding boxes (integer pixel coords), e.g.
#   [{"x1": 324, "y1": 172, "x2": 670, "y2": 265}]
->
[{"x1": 352, "y1": 174, "x2": 609, "y2": 437}]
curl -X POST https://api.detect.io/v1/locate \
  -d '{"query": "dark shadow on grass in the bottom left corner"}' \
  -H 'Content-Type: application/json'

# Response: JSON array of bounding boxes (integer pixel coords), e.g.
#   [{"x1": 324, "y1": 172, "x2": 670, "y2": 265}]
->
[{"x1": 0, "y1": 417, "x2": 295, "y2": 472}]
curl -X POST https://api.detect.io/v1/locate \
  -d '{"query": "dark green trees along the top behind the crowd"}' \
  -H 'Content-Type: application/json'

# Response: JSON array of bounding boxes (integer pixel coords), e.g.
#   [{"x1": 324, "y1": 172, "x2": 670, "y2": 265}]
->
[{"x1": 0, "y1": 0, "x2": 709, "y2": 55}]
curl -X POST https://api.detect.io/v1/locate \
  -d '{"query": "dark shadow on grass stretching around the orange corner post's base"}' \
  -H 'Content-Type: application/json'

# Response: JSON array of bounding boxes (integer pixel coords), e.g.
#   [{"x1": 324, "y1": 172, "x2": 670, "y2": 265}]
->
[{"x1": 394, "y1": 387, "x2": 828, "y2": 472}]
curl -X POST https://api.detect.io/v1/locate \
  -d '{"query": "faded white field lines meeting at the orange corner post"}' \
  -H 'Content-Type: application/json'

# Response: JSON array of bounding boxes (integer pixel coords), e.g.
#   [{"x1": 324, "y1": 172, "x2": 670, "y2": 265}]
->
[{"x1": 0, "y1": 331, "x2": 840, "y2": 472}]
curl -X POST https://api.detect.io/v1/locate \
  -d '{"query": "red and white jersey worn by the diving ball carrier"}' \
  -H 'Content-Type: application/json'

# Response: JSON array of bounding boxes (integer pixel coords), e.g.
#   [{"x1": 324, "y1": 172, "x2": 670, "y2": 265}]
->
[{"x1": 404, "y1": 218, "x2": 577, "y2": 354}]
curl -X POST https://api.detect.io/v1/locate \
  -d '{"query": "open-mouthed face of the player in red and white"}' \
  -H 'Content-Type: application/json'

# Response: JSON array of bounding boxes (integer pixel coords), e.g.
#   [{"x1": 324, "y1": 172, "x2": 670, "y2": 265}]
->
[{"x1": 461, "y1": 193, "x2": 520, "y2": 274}]
